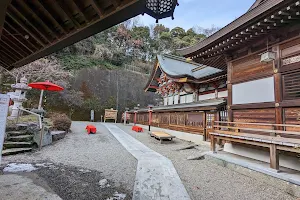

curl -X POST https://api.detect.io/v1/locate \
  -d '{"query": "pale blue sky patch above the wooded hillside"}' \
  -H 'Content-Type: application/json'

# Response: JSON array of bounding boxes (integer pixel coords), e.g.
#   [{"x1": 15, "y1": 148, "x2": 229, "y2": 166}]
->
[{"x1": 139, "y1": 0, "x2": 255, "y2": 30}]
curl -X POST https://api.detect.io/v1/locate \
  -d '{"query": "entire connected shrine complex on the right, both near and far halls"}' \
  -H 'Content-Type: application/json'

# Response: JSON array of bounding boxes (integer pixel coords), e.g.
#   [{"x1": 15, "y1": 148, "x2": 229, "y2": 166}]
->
[{"x1": 135, "y1": 0, "x2": 300, "y2": 170}]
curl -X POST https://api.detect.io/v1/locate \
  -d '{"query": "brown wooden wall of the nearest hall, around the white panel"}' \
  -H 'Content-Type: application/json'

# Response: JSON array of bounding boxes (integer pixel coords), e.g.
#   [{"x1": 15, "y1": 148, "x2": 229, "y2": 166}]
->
[{"x1": 227, "y1": 37, "x2": 300, "y2": 131}]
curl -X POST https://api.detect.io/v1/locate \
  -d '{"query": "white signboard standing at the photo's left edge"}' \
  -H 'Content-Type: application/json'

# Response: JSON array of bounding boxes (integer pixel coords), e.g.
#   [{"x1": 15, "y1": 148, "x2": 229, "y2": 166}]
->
[{"x1": 0, "y1": 94, "x2": 9, "y2": 163}]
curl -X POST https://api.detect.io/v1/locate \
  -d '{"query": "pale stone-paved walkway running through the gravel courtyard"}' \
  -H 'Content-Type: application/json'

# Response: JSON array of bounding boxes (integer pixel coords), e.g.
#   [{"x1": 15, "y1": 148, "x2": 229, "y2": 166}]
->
[{"x1": 105, "y1": 124, "x2": 190, "y2": 200}]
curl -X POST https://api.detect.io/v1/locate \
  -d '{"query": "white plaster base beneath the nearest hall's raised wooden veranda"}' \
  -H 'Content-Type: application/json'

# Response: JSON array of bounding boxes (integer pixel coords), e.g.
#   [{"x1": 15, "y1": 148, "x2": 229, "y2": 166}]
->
[{"x1": 224, "y1": 143, "x2": 300, "y2": 171}]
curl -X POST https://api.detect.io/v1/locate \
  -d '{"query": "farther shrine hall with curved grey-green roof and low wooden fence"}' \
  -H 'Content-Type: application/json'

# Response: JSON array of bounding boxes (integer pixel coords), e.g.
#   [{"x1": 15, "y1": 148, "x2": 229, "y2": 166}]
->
[{"x1": 131, "y1": 55, "x2": 227, "y2": 140}]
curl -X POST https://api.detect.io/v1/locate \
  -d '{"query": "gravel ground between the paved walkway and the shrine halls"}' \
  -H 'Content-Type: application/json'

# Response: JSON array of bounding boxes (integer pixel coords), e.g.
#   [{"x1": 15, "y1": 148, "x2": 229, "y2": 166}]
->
[{"x1": 118, "y1": 124, "x2": 297, "y2": 200}]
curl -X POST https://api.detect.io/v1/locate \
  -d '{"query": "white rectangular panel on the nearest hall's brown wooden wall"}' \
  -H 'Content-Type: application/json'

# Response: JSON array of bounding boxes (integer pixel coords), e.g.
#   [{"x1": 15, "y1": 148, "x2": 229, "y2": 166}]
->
[{"x1": 232, "y1": 77, "x2": 275, "y2": 104}]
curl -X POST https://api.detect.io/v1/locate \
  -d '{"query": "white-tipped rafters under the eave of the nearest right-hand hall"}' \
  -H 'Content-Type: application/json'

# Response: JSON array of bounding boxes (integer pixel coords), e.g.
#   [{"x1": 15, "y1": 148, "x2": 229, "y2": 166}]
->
[{"x1": 183, "y1": 1, "x2": 300, "y2": 67}]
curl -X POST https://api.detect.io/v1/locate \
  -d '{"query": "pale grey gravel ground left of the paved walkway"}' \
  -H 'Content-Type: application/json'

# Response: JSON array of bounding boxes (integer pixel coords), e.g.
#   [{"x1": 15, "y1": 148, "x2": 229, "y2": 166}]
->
[{"x1": 2, "y1": 122, "x2": 137, "y2": 199}]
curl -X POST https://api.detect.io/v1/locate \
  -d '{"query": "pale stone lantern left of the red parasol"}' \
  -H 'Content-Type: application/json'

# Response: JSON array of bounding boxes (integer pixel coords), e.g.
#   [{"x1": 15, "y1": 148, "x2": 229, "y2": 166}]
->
[{"x1": 8, "y1": 77, "x2": 31, "y2": 119}]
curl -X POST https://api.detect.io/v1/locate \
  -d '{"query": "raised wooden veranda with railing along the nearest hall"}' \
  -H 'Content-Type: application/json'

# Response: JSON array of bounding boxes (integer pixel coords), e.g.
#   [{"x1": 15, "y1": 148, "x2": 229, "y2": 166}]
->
[{"x1": 210, "y1": 121, "x2": 300, "y2": 170}]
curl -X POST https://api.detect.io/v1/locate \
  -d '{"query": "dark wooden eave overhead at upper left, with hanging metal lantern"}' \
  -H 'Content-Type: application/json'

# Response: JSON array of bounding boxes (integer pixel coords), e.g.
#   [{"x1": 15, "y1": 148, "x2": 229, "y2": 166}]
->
[{"x1": 0, "y1": 0, "x2": 178, "y2": 70}]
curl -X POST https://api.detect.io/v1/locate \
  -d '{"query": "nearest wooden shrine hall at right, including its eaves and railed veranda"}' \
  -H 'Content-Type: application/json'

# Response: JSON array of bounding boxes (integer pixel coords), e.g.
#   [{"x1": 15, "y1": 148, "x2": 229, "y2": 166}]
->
[{"x1": 178, "y1": 0, "x2": 300, "y2": 170}]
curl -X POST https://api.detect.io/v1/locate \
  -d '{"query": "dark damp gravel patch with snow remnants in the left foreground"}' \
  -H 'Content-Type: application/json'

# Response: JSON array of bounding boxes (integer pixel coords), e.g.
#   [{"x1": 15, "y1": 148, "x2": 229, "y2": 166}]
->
[{"x1": 4, "y1": 162, "x2": 132, "y2": 200}]
